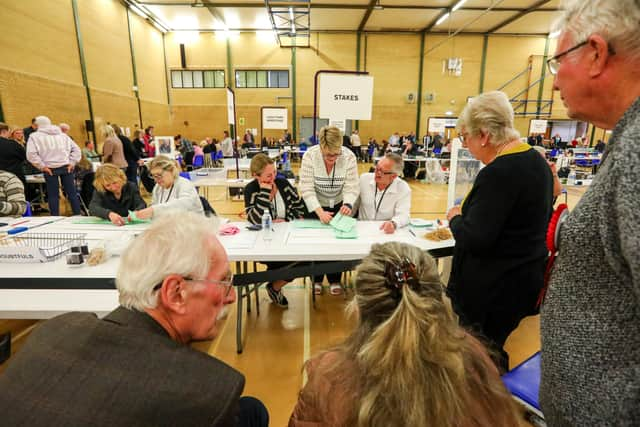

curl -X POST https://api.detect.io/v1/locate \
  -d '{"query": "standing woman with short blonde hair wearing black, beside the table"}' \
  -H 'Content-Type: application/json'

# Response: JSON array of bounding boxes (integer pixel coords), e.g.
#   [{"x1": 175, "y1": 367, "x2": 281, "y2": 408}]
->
[{"x1": 447, "y1": 91, "x2": 553, "y2": 366}]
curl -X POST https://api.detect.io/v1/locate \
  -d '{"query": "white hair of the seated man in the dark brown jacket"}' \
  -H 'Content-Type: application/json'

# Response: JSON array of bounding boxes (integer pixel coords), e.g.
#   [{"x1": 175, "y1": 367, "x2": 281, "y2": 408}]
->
[{"x1": 116, "y1": 212, "x2": 218, "y2": 311}]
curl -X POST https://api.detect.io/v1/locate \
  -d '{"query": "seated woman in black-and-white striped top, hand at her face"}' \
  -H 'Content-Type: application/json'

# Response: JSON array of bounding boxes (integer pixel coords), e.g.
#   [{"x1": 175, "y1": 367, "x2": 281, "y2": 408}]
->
[{"x1": 244, "y1": 153, "x2": 306, "y2": 307}]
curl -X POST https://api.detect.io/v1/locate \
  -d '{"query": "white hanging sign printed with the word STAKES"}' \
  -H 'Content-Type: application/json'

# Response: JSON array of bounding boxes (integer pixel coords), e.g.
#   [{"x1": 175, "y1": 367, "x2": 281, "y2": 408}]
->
[{"x1": 319, "y1": 74, "x2": 373, "y2": 120}]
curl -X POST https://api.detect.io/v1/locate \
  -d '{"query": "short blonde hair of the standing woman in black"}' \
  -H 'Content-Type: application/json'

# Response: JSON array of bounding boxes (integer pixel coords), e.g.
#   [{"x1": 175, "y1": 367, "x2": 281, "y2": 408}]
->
[{"x1": 456, "y1": 90, "x2": 520, "y2": 145}]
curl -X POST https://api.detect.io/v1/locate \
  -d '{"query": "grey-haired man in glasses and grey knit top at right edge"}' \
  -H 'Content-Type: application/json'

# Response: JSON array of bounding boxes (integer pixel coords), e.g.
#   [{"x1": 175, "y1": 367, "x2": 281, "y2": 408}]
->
[{"x1": 540, "y1": 0, "x2": 640, "y2": 426}]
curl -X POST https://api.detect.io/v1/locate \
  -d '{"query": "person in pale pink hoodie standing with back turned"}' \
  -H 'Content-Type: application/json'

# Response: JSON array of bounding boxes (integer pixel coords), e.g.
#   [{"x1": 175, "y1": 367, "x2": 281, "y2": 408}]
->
[{"x1": 27, "y1": 116, "x2": 81, "y2": 216}]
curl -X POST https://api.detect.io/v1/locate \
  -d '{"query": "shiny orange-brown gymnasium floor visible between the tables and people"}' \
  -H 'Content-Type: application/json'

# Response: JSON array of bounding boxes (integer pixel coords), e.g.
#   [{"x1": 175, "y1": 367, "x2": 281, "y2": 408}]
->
[{"x1": 0, "y1": 163, "x2": 585, "y2": 426}]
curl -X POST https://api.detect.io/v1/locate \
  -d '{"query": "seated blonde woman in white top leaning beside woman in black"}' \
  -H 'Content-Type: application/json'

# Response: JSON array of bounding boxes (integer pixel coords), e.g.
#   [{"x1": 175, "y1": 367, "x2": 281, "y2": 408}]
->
[{"x1": 136, "y1": 156, "x2": 204, "y2": 219}]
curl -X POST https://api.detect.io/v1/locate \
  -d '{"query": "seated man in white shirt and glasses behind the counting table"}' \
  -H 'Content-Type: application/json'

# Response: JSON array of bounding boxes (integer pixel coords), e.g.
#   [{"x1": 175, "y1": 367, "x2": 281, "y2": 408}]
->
[{"x1": 358, "y1": 153, "x2": 411, "y2": 234}]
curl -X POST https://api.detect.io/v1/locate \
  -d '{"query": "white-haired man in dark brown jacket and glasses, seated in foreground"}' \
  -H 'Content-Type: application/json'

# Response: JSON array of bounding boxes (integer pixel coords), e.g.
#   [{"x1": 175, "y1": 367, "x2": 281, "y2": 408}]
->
[{"x1": 0, "y1": 212, "x2": 268, "y2": 427}]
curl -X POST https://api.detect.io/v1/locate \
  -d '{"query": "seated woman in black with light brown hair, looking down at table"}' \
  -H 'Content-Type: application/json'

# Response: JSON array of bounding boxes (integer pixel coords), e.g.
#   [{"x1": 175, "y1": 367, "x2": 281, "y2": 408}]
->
[{"x1": 89, "y1": 164, "x2": 147, "y2": 225}]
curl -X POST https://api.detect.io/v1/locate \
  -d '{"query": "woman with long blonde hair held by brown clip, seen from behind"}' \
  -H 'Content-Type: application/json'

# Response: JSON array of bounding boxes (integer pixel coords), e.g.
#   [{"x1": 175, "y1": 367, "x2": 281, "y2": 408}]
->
[{"x1": 289, "y1": 242, "x2": 518, "y2": 427}]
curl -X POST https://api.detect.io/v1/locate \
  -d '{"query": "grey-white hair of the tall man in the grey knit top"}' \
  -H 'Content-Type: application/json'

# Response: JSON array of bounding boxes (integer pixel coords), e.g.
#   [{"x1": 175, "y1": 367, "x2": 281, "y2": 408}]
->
[{"x1": 553, "y1": 0, "x2": 640, "y2": 60}]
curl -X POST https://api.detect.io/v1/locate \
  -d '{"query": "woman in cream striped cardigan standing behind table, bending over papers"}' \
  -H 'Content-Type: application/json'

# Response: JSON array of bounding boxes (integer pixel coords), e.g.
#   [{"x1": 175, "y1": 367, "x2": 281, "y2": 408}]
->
[{"x1": 300, "y1": 126, "x2": 360, "y2": 295}]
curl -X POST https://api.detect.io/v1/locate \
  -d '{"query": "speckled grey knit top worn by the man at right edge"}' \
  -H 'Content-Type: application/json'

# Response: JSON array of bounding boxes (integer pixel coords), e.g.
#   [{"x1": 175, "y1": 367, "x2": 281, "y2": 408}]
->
[{"x1": 540, "y1": 98, "x2": 640, "y2": 426}]
